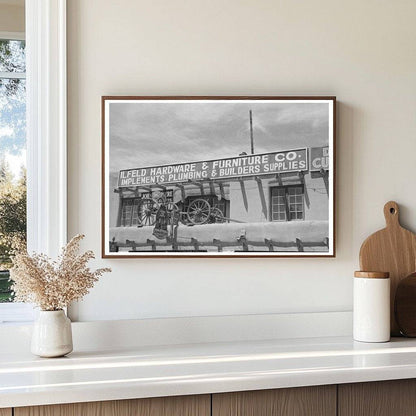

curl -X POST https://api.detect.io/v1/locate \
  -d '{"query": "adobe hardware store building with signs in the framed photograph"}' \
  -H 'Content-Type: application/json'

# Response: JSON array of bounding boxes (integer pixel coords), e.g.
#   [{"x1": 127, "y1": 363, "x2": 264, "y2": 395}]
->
[{"x1": 110, "y1": 147, "x2": 329, "y2": 251}]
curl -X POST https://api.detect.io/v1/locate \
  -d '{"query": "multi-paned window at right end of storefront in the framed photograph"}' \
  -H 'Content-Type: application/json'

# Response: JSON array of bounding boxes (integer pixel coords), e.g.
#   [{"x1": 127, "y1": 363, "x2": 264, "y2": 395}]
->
[{"x1": 270, "y1": 185, "x2": 305, "y2": 221}]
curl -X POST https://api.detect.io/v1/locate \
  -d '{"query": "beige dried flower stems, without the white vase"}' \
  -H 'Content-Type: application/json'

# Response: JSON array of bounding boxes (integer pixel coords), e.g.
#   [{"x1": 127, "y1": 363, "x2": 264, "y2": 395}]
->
[{"x1": 10, "y1": 234, "x2": 111, "y2": 311}]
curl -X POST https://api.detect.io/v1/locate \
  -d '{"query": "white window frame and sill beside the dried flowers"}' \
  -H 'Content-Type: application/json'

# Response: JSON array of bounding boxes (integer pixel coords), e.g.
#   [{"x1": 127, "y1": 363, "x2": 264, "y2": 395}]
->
[{"x1": 0, "y1": 0, "x2": 67, "y2": 324}]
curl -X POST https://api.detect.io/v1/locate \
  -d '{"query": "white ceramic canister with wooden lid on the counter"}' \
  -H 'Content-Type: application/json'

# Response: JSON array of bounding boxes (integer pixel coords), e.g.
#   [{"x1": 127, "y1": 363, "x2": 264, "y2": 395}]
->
[{"x1": 353, "y1": 272, "x2": 390, "y2": 342}]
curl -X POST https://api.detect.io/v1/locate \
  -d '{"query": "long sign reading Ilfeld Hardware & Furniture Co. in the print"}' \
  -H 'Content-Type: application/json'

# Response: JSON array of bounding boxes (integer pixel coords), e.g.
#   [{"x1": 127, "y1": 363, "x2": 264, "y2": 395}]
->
[{"x1": 118, "y1": 149, "x2": 308, "y2": 187}]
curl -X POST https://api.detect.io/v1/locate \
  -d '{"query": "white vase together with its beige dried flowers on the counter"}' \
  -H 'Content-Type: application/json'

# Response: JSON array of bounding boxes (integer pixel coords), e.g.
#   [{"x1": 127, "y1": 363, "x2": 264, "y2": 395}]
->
[{"x1": 10, "y1": 235, "x2": 111, "y2": 357}]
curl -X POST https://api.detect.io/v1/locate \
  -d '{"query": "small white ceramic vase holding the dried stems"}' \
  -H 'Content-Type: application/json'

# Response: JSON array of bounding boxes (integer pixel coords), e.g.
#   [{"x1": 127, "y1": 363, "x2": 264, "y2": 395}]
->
[{"x1": 30, "y1": 309, "x2": 72, "y2": 358}]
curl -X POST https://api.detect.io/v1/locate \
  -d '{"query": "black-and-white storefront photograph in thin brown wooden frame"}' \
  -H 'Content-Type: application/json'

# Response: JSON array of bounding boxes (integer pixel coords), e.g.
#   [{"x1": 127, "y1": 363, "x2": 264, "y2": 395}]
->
[{"x1": 102, "y1": 96, "x2": 336, "y2": 258}]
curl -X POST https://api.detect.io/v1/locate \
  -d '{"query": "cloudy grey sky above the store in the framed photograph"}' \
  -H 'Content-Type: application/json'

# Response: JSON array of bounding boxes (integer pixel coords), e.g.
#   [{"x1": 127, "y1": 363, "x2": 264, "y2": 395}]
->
[{"x1": 109, "y1": 102, "x2": 329, "y2": 173}]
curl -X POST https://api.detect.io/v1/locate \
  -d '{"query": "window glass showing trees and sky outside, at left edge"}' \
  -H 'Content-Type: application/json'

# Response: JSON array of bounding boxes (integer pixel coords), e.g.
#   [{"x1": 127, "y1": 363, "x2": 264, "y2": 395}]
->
[{"x1": 0, "y1": 40, "x2": 26, "y2": 302}]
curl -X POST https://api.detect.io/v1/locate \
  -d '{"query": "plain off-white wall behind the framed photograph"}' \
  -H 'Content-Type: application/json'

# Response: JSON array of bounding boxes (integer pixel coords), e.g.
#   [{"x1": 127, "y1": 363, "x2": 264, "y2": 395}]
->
[{"x1": 68, "y1": 0, "x2": 416, "y2": 320}]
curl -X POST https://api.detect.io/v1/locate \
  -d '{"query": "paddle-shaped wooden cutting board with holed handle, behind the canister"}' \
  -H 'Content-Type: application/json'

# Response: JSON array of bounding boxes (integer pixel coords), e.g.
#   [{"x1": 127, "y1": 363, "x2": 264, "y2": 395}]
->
[{"x1": 360, "y1": 201, "x2": 416, "y2": 336}]
